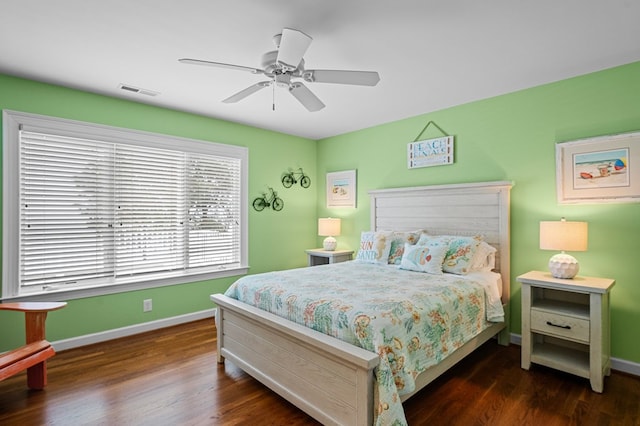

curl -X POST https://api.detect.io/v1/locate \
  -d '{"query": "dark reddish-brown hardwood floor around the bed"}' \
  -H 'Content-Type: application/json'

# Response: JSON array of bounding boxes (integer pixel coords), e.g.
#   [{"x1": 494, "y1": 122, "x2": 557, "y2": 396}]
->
[{"x1": 0, "y1": 320, "x2": 640, "y2": 426}]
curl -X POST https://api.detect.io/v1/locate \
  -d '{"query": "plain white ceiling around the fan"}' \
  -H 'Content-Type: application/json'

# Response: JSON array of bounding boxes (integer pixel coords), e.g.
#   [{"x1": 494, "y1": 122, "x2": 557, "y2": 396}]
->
[{"x1": 0, "y1": 0, "x2": 640, "y2": 139}]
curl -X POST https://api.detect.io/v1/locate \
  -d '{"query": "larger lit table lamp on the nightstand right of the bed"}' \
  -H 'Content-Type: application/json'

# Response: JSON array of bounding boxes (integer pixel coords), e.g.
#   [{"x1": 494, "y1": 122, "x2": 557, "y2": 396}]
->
[{"x1": 540, "y1": 218, "x2": 588, "y2": 279}]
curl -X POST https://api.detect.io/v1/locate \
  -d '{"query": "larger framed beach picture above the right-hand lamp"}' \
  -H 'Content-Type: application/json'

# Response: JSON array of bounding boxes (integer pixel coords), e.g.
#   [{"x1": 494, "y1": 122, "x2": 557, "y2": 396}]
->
[{"x1": 556, "y1": 132, "x2": 640, "y2": 204}]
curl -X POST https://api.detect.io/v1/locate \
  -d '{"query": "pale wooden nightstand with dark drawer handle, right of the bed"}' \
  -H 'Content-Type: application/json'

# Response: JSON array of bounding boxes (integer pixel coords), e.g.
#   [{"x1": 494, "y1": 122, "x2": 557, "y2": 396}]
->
[{"x1": 517, "y1": 271, "x2": 615, "y2": 393}]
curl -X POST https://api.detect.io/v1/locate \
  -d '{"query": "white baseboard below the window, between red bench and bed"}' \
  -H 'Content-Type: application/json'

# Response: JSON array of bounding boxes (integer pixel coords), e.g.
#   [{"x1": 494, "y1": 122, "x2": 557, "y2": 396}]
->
[{"x1": 51, "y1": 308, "x2": 216, "y2": 351}]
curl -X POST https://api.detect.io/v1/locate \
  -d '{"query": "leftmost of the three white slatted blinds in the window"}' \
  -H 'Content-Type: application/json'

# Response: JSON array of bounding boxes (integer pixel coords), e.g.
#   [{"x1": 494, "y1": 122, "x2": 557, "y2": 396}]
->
[{"x1": 19, "y1": 132, "x2": 114, "y2": 286}]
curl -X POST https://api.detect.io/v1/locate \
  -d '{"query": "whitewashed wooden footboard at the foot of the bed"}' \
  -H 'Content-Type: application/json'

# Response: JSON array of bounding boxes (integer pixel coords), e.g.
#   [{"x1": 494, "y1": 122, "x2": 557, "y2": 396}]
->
[{"x1": 211, "y1": 294, "x2": 379, "y2": 425}]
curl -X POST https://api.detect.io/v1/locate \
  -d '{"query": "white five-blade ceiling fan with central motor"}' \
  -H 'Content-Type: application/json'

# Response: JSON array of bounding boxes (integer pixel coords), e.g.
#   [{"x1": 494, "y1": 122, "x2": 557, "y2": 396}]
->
[{"x1": 178, "y1": 28, "x2": 380, "y2": 112}]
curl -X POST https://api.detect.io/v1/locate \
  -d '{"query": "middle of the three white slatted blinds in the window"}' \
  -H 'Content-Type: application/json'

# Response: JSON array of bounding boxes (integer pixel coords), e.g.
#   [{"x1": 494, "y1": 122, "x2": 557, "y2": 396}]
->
[{"x1": 113, "y1": 141, "x2": 186, "y2": 276}]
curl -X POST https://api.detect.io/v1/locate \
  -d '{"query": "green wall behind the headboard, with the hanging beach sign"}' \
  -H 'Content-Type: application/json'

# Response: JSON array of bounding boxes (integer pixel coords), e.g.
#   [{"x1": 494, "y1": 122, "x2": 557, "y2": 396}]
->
[{"x1": 318, "y1": 62, "x2": 640, "y2": 363}]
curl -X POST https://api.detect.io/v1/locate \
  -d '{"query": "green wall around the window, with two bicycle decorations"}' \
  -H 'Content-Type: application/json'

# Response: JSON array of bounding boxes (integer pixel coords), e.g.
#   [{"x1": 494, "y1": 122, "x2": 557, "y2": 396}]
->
[{"x1": 0, "y1": 74, "x2": 318, "y2": 351}]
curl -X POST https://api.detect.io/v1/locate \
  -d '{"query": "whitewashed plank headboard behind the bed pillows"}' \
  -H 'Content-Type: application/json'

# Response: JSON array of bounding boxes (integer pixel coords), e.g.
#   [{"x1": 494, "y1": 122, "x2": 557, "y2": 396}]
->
[{"x1": 369, "y1": 181, "x2": 513, "y2": 304}]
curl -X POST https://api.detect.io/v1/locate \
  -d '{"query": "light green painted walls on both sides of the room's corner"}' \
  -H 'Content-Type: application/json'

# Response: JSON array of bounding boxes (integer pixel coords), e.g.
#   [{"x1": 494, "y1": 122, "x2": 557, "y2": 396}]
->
[{"x1": 0, "y1": 62, "x2": 640, "y2": 363}]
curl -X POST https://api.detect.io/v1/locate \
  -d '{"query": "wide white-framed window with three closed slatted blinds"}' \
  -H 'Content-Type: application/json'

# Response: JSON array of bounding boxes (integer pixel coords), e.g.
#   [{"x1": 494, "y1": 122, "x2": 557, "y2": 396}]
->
[{"x1": 3, "y1": 111, "x2": 248, "y2": 299}]
